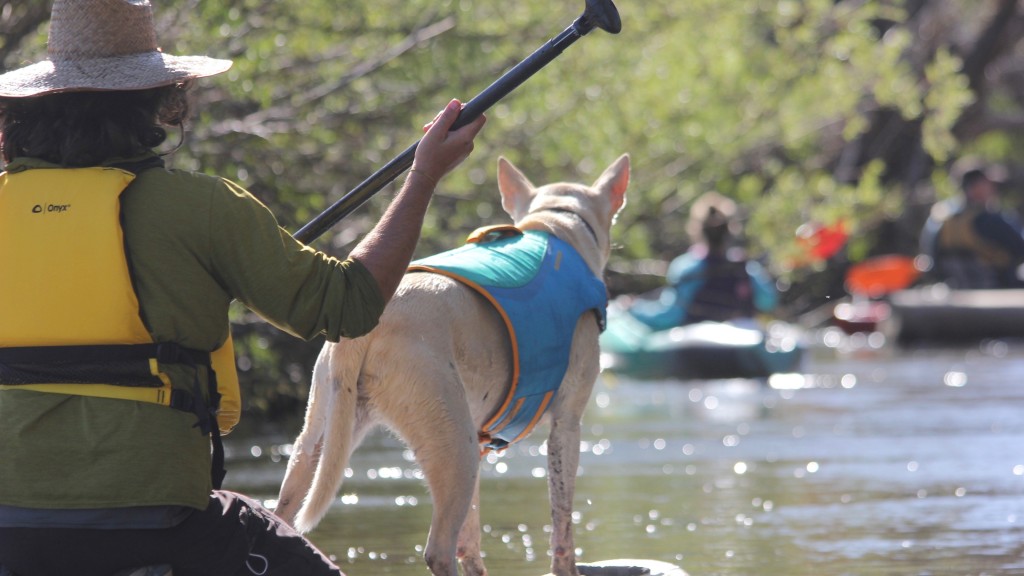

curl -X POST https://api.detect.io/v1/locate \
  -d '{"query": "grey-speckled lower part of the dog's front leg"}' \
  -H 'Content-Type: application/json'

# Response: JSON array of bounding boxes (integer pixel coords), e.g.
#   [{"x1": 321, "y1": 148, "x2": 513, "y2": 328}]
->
[{"x1": 548, "y1": 417, "x2": 580, "y2": 576}]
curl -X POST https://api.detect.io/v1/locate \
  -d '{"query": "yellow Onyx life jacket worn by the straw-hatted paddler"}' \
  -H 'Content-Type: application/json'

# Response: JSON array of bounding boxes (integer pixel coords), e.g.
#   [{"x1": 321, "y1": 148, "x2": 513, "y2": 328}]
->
[{"x1": 0, "y1": 167, "x2": 241, "y2": 434}]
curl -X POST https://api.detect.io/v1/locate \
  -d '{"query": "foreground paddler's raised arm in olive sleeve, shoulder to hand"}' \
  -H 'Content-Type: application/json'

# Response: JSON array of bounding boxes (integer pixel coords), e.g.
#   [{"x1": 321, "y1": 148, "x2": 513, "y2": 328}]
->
[{"x1": 201, "y1": 100, "x2": 484, "y2": 341}]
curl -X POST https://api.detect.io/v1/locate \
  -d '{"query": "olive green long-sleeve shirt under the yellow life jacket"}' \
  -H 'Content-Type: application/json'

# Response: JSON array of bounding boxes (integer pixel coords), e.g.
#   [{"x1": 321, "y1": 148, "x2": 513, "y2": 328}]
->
[{"x1": 0, "y1": 154, "x2": 384, "y2": 508}]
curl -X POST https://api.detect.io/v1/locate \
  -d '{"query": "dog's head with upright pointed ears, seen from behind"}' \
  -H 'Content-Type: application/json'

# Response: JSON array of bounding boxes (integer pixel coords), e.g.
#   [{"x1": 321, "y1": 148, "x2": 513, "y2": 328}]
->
[{"x1": 498, "y1": 154, "x2": 630, "y2": 277}]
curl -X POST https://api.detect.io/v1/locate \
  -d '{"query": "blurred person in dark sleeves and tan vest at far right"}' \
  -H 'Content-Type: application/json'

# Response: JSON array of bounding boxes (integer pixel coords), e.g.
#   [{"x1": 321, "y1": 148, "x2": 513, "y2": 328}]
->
[{"x1": 921, "y1": 160, "x2": 1024, "y2": 289}]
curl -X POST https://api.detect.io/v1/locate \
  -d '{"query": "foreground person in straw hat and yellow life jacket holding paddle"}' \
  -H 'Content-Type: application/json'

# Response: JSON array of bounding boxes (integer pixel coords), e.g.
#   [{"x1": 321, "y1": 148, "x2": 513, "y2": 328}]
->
[{"x1": 0, "y1": 0, "x2": 484, "y2": 576}]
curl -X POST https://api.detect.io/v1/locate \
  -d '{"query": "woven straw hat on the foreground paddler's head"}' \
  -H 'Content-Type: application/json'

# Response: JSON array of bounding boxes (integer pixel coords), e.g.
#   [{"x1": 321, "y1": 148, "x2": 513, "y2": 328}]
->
[{"x1": 0, "y1": 0, "x2": 231, "y2": 97}]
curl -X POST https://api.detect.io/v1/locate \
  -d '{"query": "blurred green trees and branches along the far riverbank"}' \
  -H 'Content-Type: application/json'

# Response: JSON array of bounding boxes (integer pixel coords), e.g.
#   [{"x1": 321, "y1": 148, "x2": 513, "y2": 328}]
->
[{"x1": 0, "y1": 0, "x2": 1024, "y2": 422}]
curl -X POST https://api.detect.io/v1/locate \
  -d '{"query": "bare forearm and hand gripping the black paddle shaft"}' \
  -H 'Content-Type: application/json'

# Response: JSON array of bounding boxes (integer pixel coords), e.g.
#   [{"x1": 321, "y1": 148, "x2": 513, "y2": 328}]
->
[{"x1": 349, "y1": 100, "x2": 485, "y2": 302}]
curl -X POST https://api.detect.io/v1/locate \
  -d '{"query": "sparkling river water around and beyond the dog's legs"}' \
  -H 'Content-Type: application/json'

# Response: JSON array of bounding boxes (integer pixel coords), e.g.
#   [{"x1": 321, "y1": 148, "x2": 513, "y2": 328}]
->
[{"x1": 225, "y1": 334, "x2": 1024, "y2": 576}]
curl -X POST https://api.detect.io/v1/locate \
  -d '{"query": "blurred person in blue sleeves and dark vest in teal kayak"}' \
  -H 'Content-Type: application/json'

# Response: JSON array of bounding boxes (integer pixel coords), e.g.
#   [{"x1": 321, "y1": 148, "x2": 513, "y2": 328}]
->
[{"x1": 630, "y1": 192, "x2": 778, "y2": 330}]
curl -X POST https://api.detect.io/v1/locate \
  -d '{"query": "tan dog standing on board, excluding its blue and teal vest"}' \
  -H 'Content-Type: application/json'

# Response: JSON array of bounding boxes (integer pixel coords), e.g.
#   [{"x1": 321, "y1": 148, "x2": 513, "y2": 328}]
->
[{"x1": 276, "y1": 155, "x2": 630, "y2": 576}]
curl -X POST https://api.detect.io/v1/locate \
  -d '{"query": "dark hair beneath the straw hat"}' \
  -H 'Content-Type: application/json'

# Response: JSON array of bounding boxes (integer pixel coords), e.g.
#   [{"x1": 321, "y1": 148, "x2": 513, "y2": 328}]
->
[{"x1": 0, "y1": 82, "x2": 190, "y2": 167}]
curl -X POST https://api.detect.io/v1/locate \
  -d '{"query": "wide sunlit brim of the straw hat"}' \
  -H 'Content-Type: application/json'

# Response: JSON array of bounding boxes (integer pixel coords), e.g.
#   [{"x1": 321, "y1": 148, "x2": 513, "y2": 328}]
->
[{"x1": 0, "y1": 52, "x2": 231, "y2": 97}]
